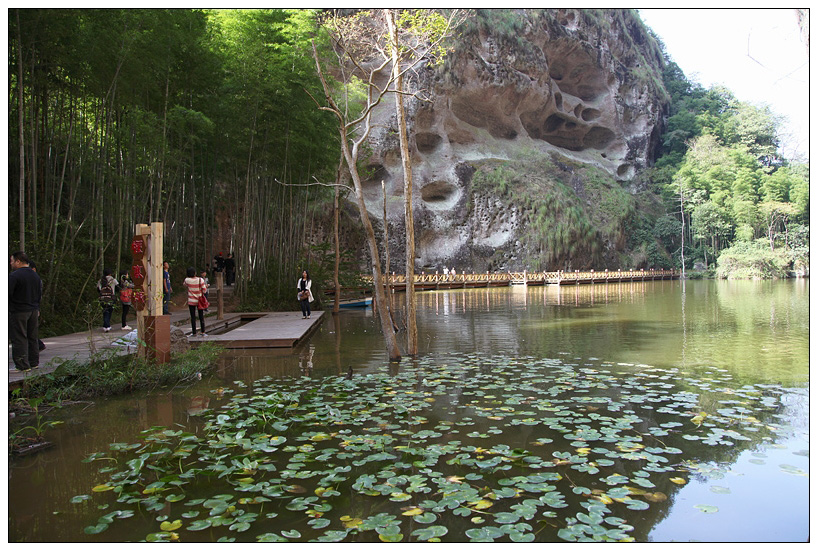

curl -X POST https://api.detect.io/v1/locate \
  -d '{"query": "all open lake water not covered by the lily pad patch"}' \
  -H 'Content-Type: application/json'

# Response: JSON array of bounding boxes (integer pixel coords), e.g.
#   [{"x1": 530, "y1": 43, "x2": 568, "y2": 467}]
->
[{"x1": 9, "y1": 280, "x2": 809, "y2": 542}]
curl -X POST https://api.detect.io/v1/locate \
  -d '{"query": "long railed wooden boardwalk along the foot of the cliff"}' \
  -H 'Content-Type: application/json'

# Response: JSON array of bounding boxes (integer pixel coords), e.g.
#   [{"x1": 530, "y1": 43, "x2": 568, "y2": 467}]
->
[{"x1": 327, "y1": 270, "x2": 680, "y2": 295}]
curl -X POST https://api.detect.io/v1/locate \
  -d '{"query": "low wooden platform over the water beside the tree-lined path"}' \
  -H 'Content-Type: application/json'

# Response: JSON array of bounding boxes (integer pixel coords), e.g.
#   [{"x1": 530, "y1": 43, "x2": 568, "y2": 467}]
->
[{"x1": 188, "y1": 311, "x2": 324, "y2": 349}]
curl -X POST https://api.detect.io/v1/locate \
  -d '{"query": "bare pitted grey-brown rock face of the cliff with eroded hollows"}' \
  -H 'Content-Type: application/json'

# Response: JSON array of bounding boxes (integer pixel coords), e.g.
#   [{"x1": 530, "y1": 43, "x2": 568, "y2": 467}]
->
[{"x1": 356, "y1": 10, "x2": 666, "y2": 270}]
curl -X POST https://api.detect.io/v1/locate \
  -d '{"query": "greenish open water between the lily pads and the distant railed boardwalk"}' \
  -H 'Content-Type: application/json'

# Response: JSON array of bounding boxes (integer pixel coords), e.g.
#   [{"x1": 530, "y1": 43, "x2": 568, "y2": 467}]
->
[{"x1": 406, "y1": 281, "x2": 809, "y2": 384}]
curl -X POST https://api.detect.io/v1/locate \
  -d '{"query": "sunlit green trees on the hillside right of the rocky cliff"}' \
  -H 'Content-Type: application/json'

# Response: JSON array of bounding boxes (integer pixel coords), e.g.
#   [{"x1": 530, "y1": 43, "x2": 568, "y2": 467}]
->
[{"x1": 651, "y1": 27, "x2": 809, "y2": 274}]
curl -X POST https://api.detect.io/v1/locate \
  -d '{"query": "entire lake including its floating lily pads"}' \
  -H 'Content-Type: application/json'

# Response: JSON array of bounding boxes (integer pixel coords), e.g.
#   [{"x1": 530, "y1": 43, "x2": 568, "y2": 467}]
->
[{"x1": 9, "y1": 280, "x2": 809, "y2": 542}]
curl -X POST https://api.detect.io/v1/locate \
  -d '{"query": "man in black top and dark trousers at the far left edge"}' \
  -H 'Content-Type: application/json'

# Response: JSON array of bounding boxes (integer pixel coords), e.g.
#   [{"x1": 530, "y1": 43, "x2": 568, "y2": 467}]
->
[{"x1": 9, "y1": 251, "x2": 43, "y2": 371}]
